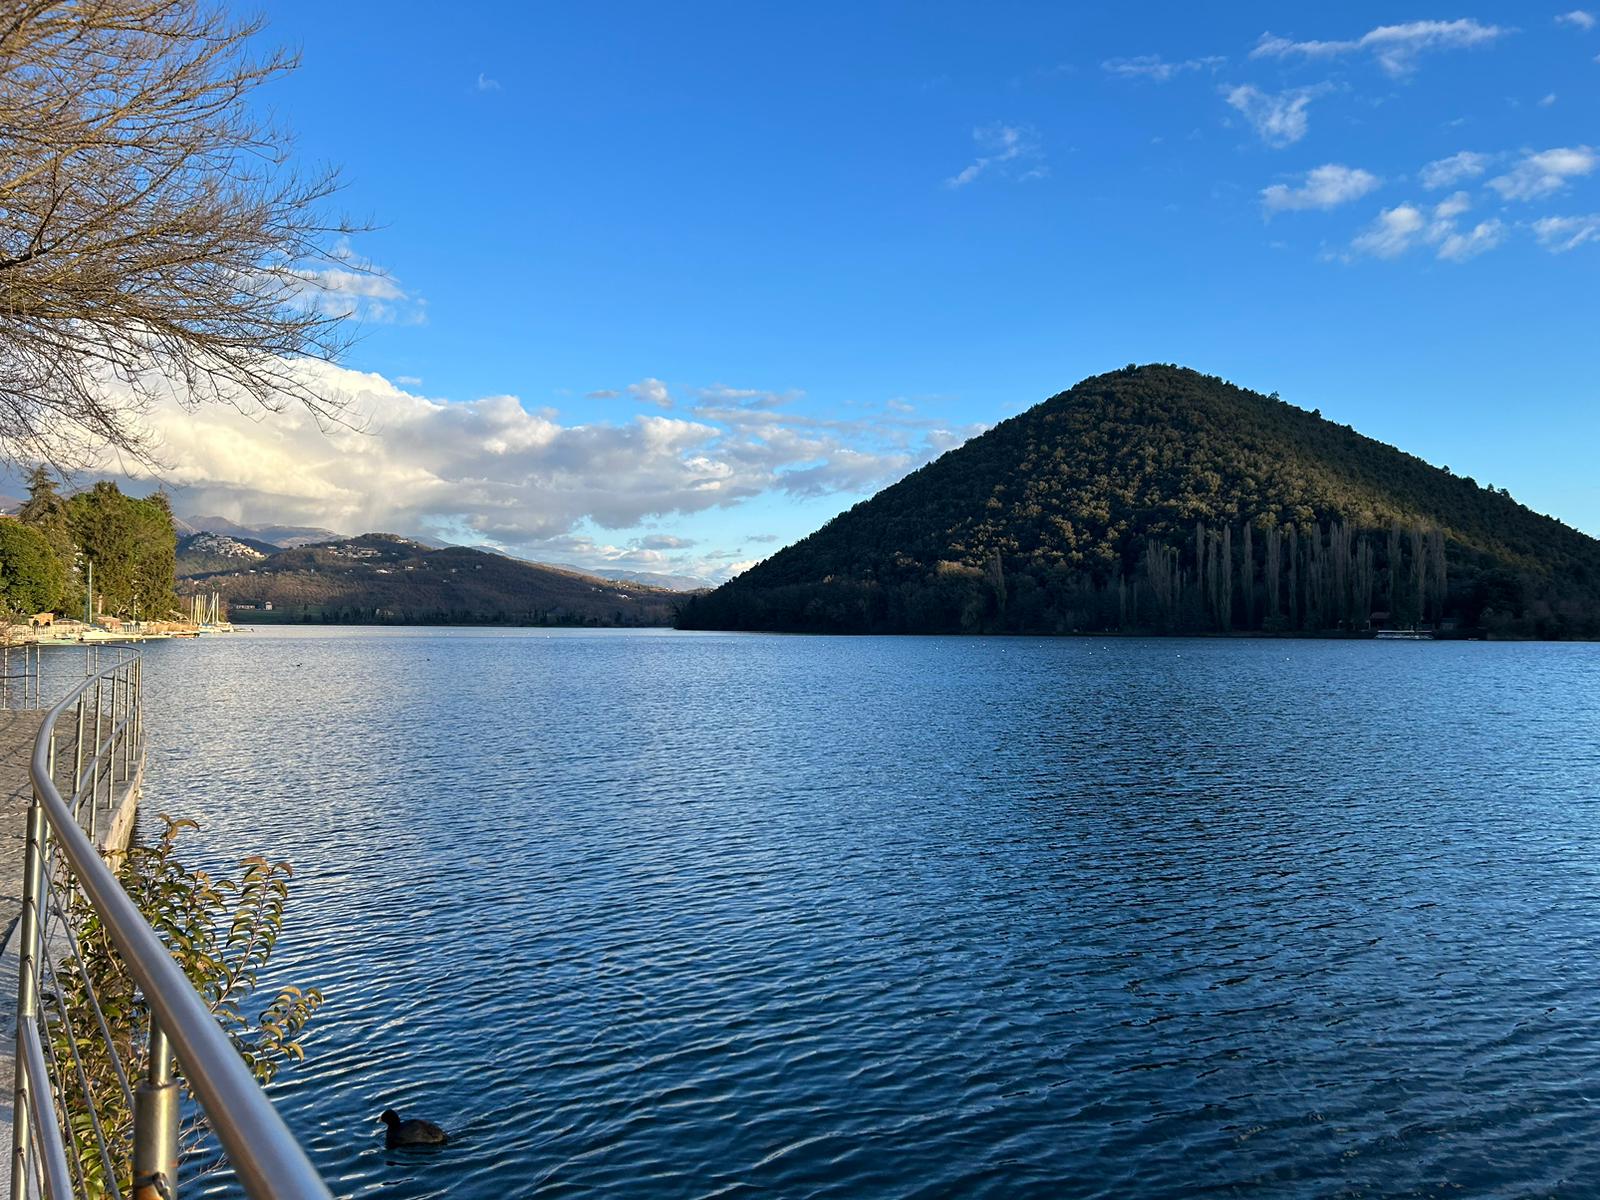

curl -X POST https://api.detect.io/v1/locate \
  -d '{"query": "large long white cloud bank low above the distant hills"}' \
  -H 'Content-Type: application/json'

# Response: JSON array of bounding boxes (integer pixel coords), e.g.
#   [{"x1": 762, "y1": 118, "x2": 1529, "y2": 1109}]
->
[{"x1": 116, "y1": 362, "x2": 979, "y2": 572}]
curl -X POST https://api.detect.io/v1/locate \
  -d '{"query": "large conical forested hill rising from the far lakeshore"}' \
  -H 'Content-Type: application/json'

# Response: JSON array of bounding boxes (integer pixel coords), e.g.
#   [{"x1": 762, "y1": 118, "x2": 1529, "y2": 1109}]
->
[{"x1": 680, "y1": 365, "x2": 1600, "y2": 637}]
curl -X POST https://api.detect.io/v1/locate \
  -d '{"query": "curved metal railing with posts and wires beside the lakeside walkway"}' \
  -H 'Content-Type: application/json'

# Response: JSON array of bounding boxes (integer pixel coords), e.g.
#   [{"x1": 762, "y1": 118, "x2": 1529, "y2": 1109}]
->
[{"x1": 11, "y1": 651, "x2": 331, "y2": 1200}]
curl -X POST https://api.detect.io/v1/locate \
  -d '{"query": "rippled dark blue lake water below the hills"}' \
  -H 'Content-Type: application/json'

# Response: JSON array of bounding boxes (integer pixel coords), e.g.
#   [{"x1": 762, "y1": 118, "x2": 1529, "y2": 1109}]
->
[{"x1": 128, "y1": 630, "x2": 1600, "y2": 1200}]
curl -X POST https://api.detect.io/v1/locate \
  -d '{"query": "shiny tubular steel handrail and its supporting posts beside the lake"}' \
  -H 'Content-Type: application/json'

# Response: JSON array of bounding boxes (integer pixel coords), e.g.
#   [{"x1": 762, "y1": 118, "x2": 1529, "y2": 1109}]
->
[{"x1": 13, "y1": 656, "x2": 331, "y2": 1200}]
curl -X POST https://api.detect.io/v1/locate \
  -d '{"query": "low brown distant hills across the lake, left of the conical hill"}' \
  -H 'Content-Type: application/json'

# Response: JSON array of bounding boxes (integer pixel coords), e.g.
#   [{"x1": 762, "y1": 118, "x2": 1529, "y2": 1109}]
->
[{"x1": 178, "y1": 534, "x2": 682, "y2": 626}]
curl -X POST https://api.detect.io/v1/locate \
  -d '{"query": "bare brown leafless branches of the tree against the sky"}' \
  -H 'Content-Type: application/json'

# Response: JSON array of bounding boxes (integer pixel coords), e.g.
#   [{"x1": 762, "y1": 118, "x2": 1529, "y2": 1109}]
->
[{"x1": 0, "y1": 0, "x2": 363, "y2": 469}]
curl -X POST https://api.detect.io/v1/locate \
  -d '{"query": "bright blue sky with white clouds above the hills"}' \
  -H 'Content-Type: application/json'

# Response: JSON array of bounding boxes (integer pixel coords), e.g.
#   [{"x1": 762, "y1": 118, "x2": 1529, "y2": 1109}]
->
[{"x1": 116, "y1": 3, "x2": 1600, "y2": 576}]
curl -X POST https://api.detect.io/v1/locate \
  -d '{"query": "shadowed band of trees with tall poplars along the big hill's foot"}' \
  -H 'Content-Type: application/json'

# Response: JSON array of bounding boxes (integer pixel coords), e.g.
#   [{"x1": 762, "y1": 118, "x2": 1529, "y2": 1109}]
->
[{"x1": 680, "y1": 522, "x2": 1561, "y2": 637}]
